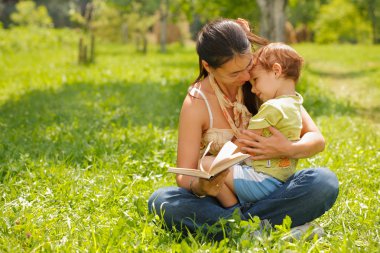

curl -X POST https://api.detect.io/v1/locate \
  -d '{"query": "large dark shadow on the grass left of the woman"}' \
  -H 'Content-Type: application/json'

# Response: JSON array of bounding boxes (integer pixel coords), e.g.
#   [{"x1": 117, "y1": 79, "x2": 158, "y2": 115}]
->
[{"x1": 0, "y1": 81, "x2": 187, "y2": 180}]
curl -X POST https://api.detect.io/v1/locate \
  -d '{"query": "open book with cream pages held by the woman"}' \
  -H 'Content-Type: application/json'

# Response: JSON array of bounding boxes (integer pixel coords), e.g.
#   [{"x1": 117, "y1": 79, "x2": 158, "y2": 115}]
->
[{"x1": 168, "y1": 141, "x2": 250, "y2": 179}]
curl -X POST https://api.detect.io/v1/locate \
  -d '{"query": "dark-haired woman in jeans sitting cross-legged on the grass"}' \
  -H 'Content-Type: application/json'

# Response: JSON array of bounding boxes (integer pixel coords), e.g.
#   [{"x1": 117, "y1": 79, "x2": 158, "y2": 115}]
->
[{"x1": 148, "y1": 19, "x2": 338, "y2": 239}]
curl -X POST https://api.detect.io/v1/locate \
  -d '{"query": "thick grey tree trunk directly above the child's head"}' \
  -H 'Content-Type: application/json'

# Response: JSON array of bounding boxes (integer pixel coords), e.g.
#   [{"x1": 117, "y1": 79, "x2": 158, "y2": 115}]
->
[{"x1": 256, "y1": 0, "x2": 288, "y2": 42}]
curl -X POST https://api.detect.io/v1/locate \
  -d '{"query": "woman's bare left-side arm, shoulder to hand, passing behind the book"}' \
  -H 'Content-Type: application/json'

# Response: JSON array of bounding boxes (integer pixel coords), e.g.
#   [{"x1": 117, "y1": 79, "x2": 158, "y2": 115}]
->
[{"x1": 176, "y1": 95, "x2": 228, "y2": 196}]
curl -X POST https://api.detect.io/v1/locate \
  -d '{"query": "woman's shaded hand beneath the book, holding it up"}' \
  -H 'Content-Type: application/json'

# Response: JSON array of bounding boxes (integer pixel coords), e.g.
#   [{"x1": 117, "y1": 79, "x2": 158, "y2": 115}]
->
[{"x1": 191, "y1": 170, "x2": 229, "y2": 197}]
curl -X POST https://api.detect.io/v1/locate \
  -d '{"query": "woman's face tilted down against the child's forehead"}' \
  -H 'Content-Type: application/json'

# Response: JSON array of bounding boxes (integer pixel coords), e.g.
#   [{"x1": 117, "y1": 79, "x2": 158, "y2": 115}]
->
[{"x1": 212, "y1": 52, "x2": 253, "y2": 87}]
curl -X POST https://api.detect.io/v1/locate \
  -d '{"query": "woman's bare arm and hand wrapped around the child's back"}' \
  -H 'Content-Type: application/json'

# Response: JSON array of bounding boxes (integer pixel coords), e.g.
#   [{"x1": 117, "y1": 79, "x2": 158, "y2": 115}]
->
[{"x1": 238, "y1": 107, "x2": 325, "y2": 160}]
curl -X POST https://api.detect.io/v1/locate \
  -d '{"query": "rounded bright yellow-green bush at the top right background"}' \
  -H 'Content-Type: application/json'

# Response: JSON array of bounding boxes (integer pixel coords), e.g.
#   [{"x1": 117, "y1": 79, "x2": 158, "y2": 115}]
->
[{"x1": 314, "y1": 0, "x2": 372, "y2": 43}]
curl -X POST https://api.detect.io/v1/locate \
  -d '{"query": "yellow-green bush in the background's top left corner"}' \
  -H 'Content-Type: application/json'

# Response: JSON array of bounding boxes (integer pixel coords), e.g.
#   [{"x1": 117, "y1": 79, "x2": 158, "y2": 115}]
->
[{"x1": 11, "y1": 1, "x2": 53, "y2": 27}]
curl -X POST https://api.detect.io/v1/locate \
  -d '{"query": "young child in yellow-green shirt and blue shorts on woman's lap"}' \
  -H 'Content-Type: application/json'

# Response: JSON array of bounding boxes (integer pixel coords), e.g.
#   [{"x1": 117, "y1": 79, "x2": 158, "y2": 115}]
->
[{"x1": 202, "y1": 43, "x2": 303, "y2": 207}]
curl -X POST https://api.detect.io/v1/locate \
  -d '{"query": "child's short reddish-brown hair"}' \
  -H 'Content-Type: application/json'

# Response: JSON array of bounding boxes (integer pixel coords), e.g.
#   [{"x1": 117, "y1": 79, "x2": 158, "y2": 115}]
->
[{"x1": 253, "y1": 42, "x2": 303, "y2": 82}]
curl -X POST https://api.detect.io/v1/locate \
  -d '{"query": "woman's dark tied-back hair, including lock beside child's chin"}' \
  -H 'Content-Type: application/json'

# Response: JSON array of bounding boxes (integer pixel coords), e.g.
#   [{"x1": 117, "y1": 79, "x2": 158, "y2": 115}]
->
[{"x1": 194, "y1": 19, "x2": 268, "y2": 114}]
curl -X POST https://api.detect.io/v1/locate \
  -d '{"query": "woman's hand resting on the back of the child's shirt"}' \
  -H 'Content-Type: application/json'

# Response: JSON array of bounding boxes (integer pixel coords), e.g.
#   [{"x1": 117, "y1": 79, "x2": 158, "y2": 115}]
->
[{"x1": 238, "y1": 127, "x2": 293, "y2": 160}]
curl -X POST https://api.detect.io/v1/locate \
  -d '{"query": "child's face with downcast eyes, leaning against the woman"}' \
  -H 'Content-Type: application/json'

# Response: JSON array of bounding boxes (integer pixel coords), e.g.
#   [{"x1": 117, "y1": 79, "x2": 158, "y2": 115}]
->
[{"x1": 250, "y1": 65, "x2": 280, "y2": 102}]
